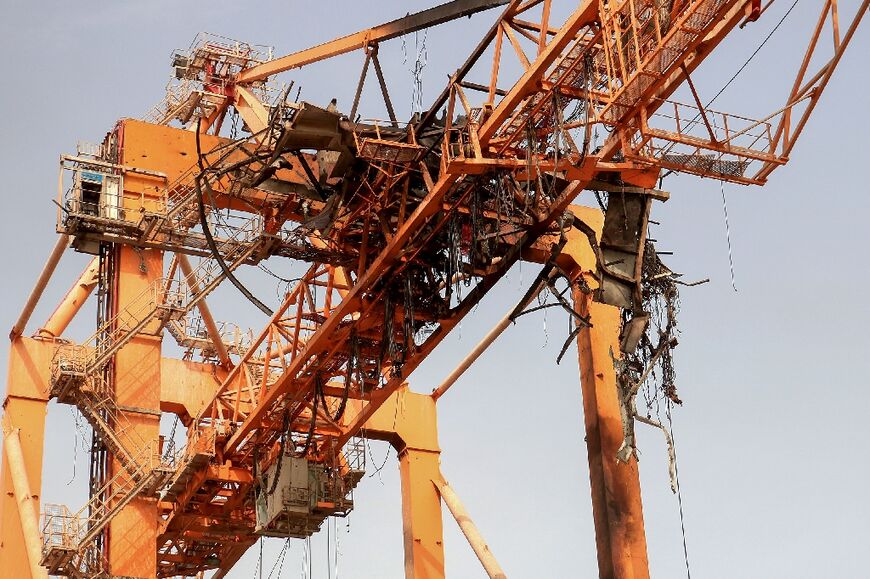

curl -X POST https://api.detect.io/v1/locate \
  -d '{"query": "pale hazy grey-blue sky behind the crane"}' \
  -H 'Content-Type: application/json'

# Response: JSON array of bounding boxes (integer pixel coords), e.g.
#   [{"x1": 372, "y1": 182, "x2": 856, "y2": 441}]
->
[{"x1": 0, "y1": 0, "x2": 870, "y2": 579}]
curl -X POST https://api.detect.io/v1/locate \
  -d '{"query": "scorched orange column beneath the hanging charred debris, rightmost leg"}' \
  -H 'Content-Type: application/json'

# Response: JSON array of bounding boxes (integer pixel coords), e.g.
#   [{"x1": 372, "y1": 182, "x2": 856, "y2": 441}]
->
[{"x1": 573, "y1": 288, "x2": 649, "y2": 579}]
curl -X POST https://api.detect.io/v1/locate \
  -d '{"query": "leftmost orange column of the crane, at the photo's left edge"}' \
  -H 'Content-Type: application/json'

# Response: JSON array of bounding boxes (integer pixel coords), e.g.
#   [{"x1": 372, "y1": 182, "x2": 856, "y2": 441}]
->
[{"x1": 0, "y1": 338, "x2": 54, "y2": 578}]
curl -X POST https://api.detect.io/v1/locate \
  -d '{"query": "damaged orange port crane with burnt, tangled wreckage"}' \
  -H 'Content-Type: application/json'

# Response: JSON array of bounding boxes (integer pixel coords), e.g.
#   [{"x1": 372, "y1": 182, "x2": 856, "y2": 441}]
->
[{"x1": 0, "y1": 0, "x2": 870, "y2": 579}]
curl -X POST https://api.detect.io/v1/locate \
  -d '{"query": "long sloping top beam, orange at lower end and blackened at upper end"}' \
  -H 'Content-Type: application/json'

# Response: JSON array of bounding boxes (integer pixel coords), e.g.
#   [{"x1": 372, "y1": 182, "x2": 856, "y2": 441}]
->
[{"x1": 236, "y1": 0, "x2": 508, "y2": 83}]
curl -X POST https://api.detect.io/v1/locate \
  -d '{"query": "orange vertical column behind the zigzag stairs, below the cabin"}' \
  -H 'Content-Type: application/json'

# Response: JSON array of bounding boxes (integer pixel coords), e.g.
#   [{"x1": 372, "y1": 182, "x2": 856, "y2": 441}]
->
[{"x1": 107, "y1": 246, "x2": 163, "y2": 577}]
